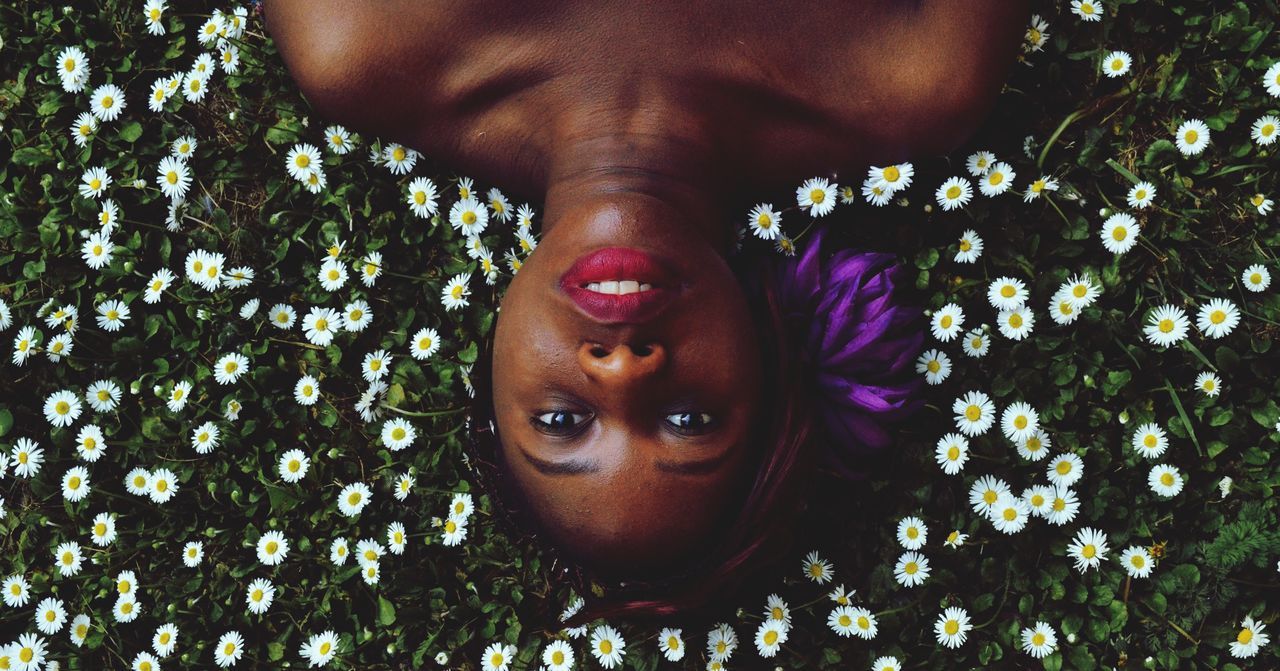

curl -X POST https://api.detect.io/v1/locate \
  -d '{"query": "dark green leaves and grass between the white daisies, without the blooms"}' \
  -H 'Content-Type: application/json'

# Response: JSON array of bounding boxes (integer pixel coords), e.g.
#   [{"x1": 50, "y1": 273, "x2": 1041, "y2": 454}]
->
[{"x1": 0, "y1": 0, "x2": 1280, "y2": 670}]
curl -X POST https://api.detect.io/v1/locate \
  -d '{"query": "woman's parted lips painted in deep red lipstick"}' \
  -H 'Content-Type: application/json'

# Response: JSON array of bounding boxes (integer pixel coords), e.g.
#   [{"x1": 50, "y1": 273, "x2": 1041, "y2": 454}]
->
[{"x1": 561, "y1": 247, "x2": 681, "y2": 324}]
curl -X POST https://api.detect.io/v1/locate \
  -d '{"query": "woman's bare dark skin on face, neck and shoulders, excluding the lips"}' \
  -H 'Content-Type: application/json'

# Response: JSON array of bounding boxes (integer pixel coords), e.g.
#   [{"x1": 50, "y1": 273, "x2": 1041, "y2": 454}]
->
[{"x1": 265, "y1": 0, "x2": 1029, "y2": 575}]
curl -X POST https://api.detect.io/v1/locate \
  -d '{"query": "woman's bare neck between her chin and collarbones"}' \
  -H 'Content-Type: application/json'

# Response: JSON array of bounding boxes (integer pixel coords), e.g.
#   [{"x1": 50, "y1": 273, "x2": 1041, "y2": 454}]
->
[{"x1": 543, "y1": 124, "x2": 735, "y2": 254}]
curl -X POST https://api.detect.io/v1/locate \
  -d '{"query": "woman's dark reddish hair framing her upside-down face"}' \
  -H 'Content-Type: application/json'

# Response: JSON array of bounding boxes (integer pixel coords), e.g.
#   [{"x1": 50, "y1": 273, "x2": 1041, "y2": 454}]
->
[{"x1": 467, "y1": 254, "x2": 814, "y2": 624}]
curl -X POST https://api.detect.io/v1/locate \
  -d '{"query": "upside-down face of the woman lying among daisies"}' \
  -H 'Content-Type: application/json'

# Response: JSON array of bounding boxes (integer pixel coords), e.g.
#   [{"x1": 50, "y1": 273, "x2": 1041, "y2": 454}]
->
[{"x1": 493, "y1": 195, "x2": 762, "y2": 576}]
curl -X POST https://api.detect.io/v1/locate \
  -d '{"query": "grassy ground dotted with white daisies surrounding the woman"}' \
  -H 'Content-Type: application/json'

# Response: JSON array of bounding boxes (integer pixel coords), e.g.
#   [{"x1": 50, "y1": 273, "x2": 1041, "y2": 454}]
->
[{"x1": 0, "y1": 0, "x2": 1280, "y2": 671}]
